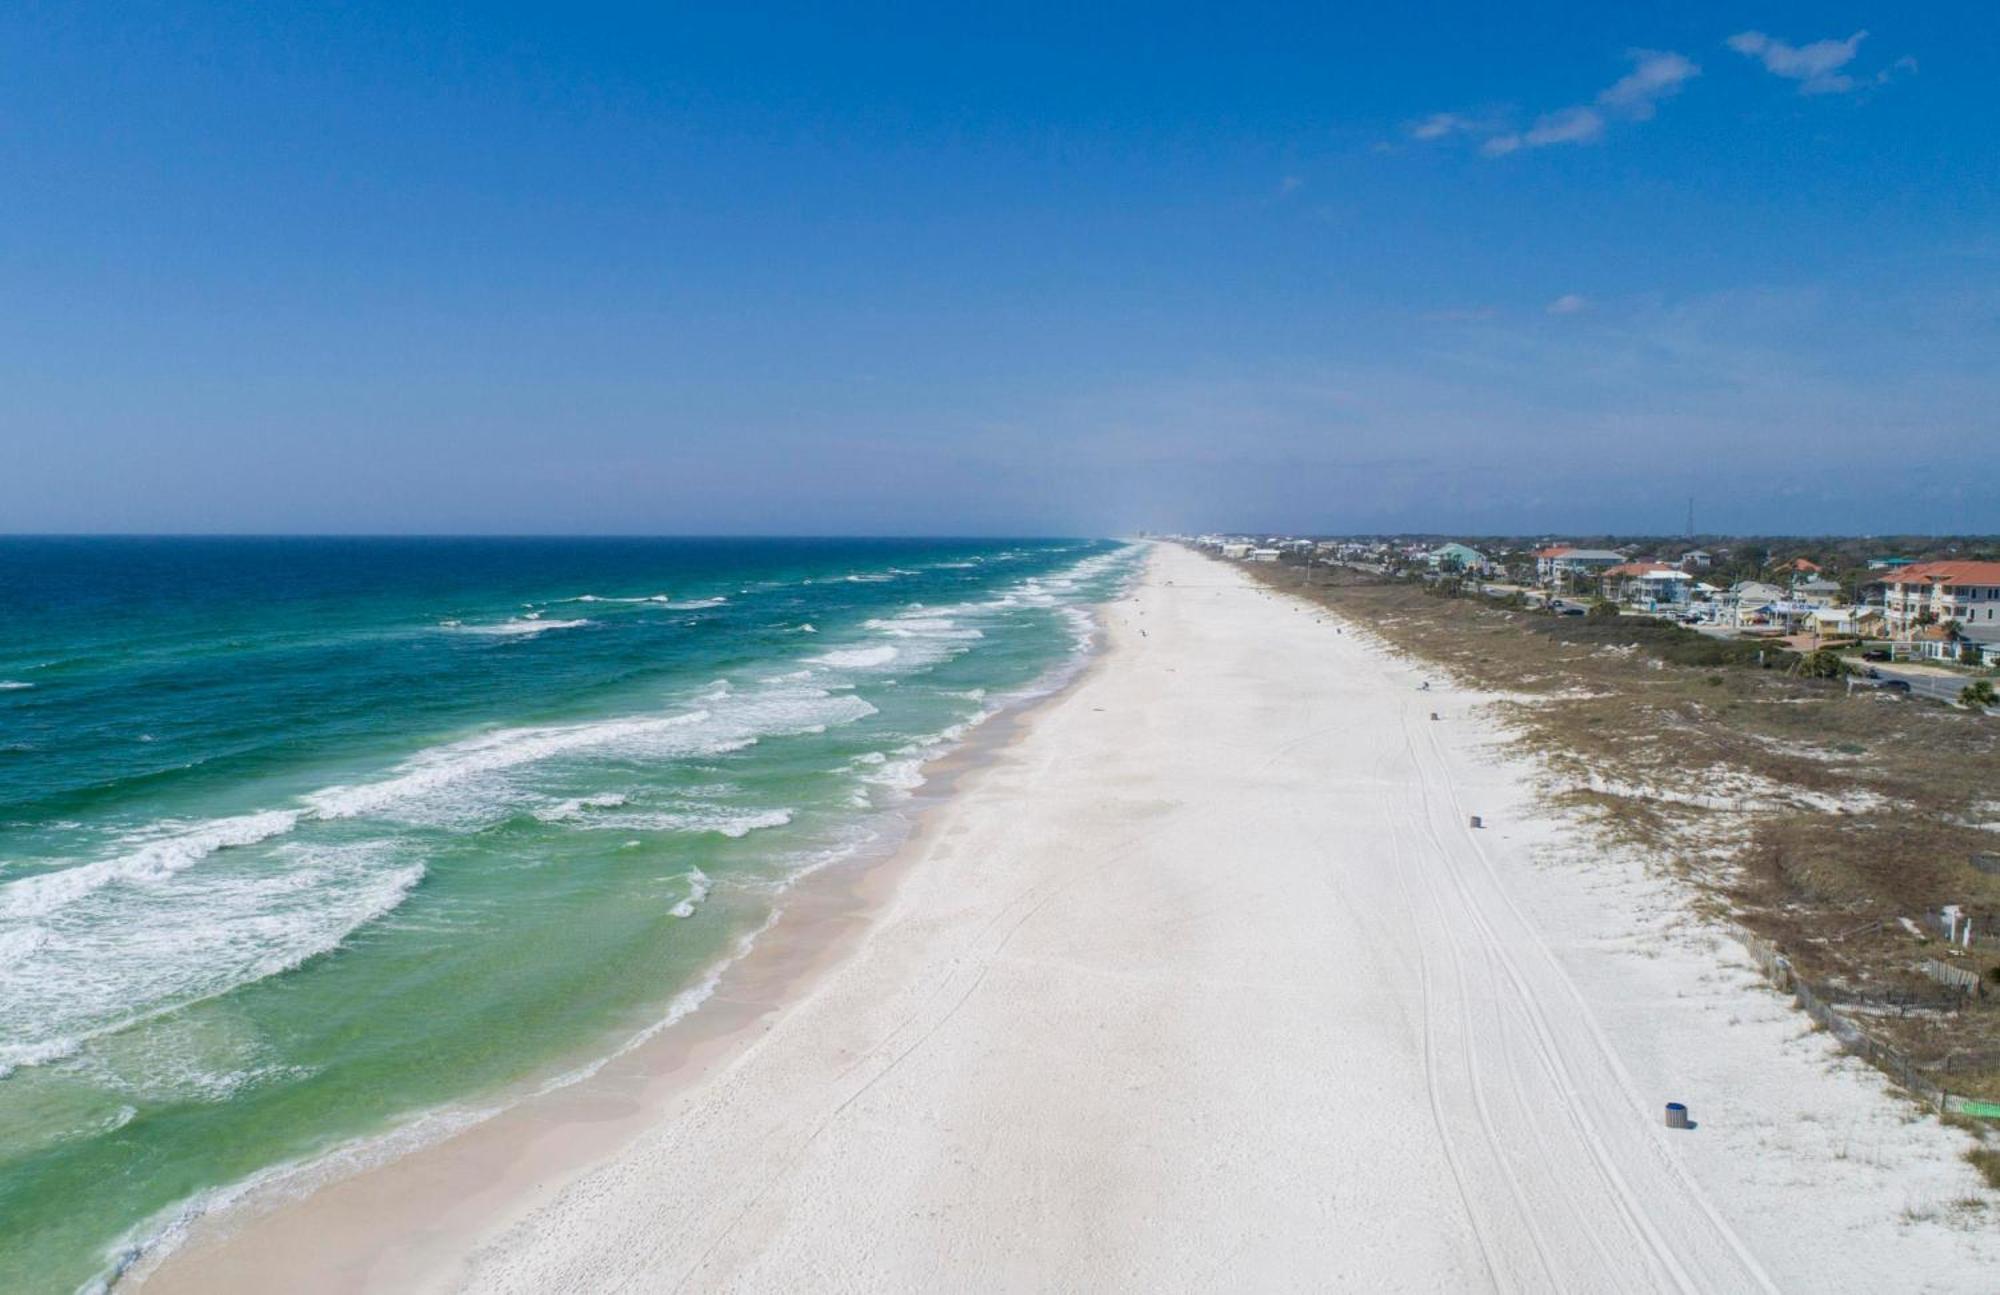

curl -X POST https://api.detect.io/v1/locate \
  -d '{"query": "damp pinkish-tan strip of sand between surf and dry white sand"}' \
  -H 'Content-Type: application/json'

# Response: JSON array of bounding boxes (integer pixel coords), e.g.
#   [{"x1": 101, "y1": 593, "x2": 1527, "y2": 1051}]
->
[{"x1": 129, "y1": 558, "x2": 1150, "y2": 1295}]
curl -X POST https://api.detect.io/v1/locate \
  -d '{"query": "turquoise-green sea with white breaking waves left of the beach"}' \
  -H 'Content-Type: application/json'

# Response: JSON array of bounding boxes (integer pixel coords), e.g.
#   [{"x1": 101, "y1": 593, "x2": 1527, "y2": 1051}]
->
[{"x1": 0, "y1": 540, "x2": 1136, "y2": 1291}]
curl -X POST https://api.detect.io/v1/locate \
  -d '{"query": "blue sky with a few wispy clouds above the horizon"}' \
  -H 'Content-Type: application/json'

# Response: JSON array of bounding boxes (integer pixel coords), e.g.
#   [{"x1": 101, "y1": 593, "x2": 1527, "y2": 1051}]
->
[{"x1": 0, "y1": 2, "x2": 2000, "y2": 534}]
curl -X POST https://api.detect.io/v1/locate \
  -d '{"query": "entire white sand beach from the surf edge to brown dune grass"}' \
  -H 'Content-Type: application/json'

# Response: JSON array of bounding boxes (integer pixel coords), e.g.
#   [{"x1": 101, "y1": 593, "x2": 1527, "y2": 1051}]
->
[{"x1": 146, "y1": 548, "x2": 2000, "y2": 1291}]
